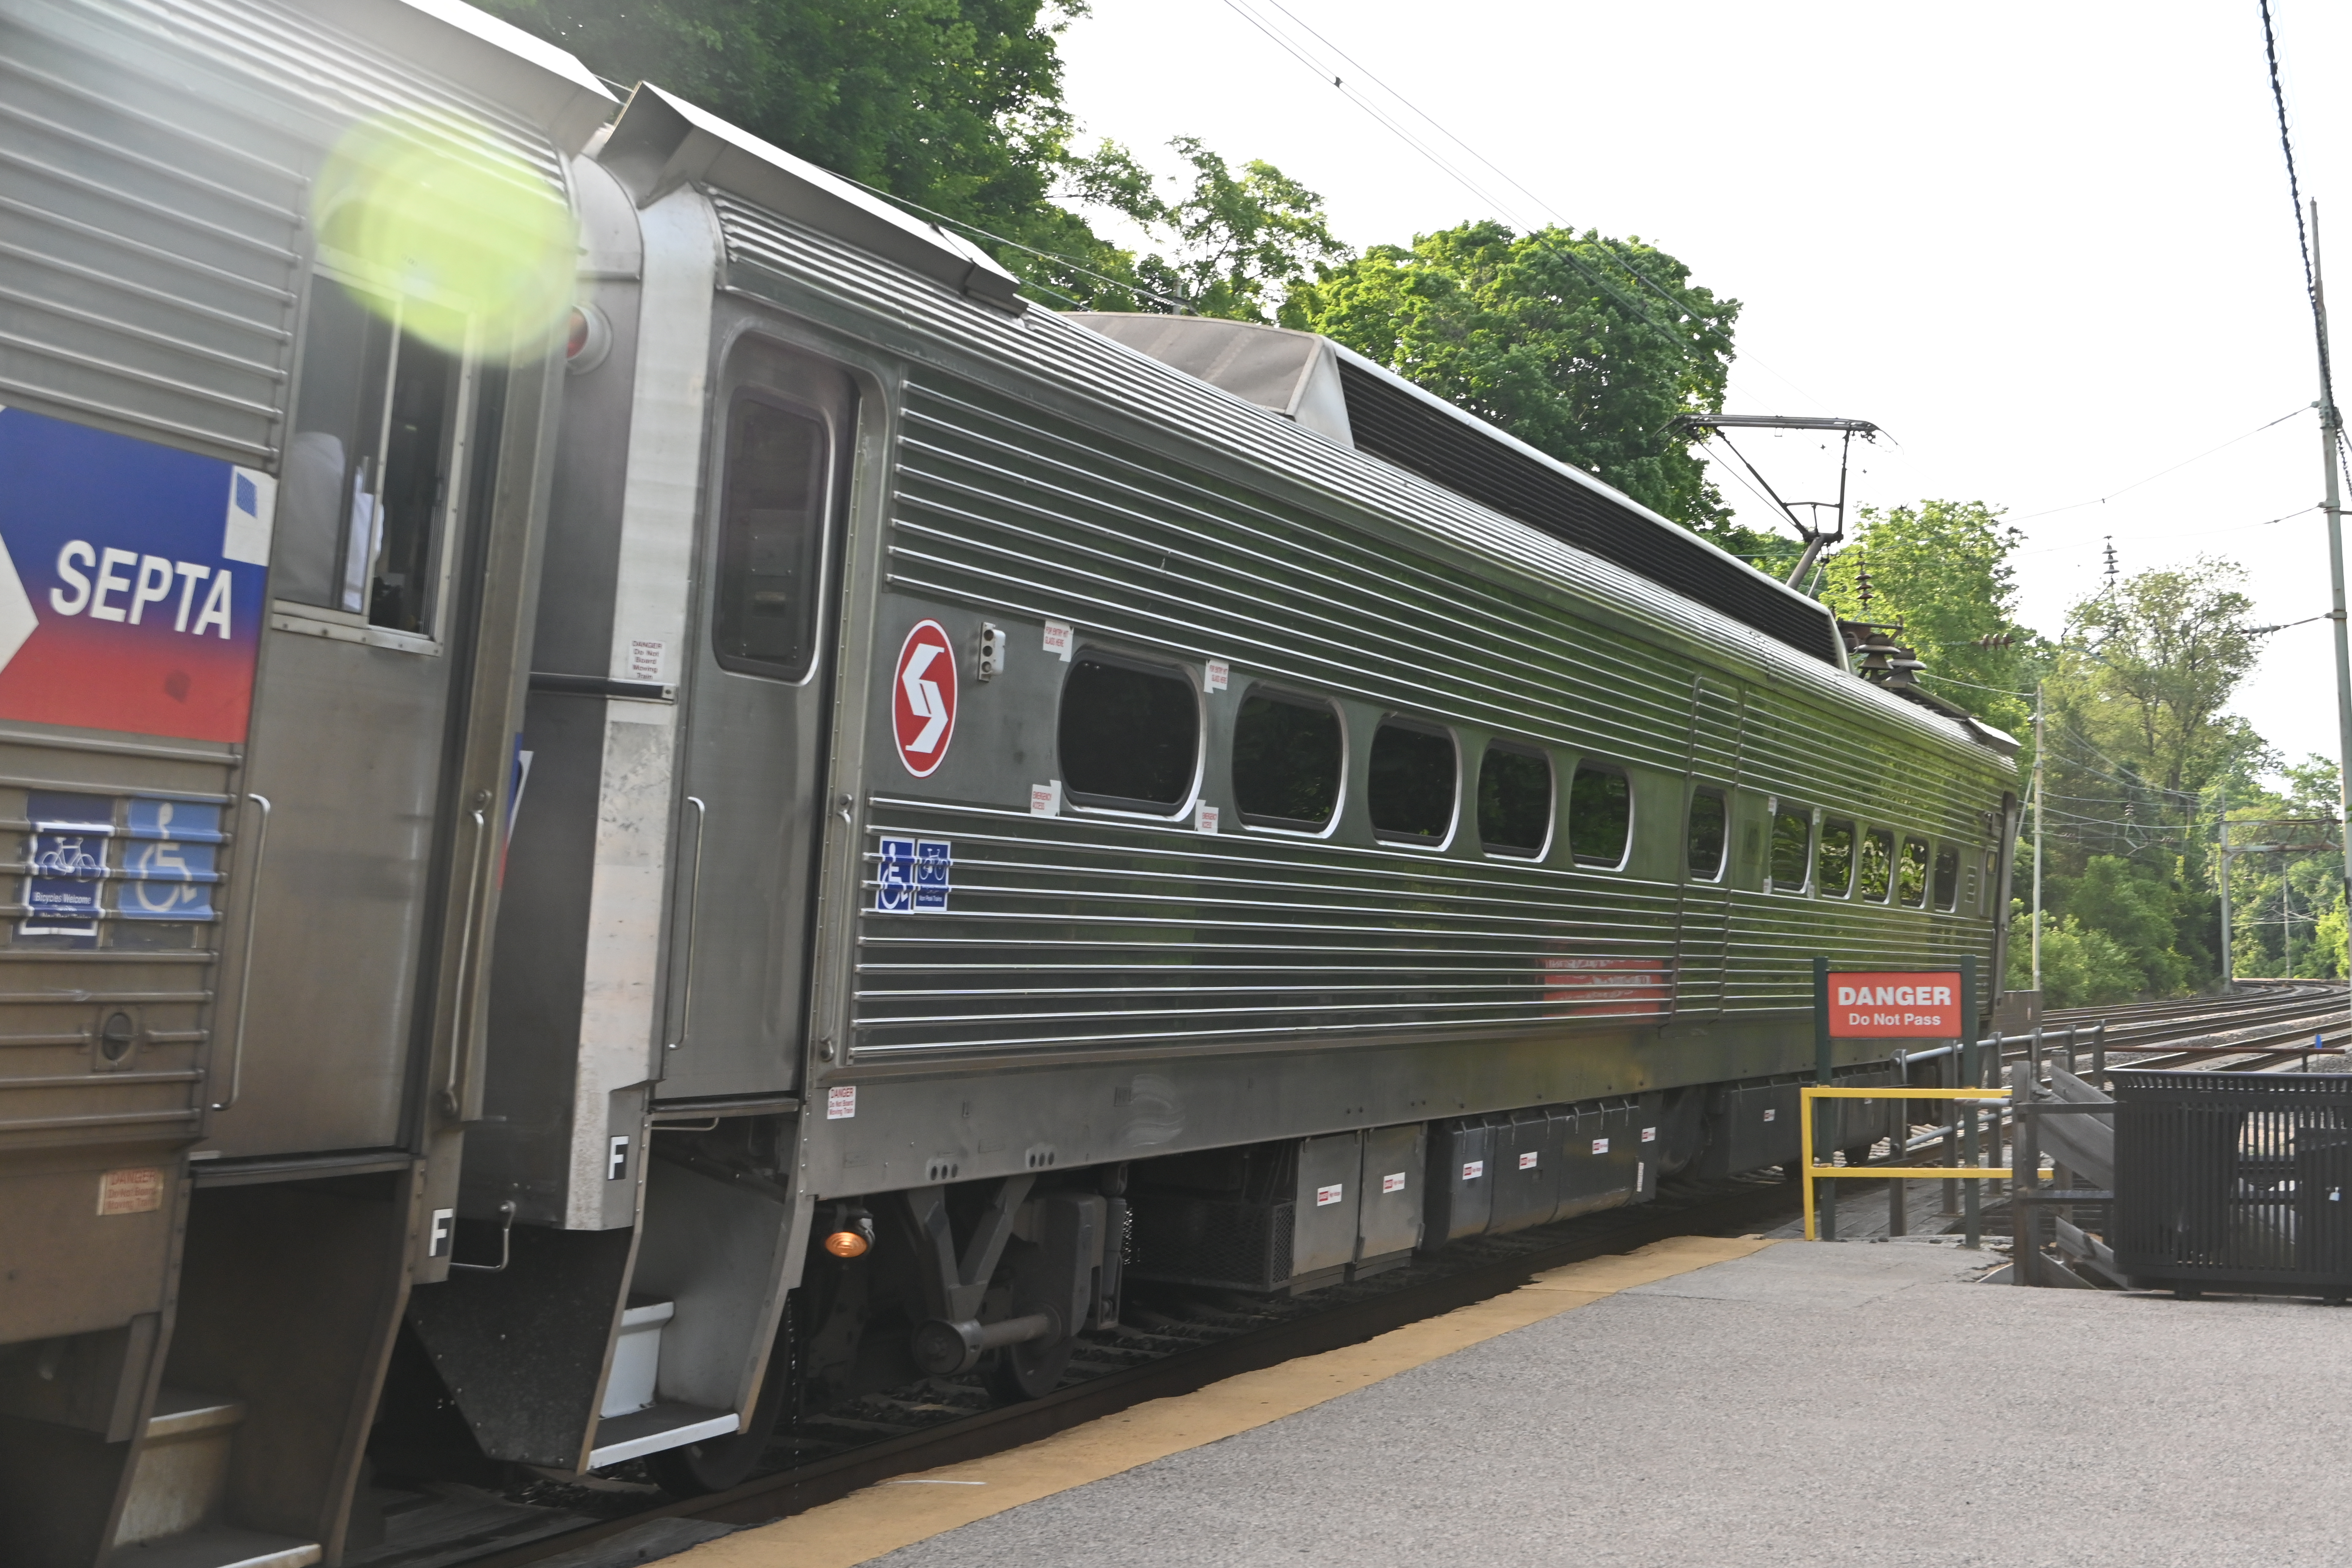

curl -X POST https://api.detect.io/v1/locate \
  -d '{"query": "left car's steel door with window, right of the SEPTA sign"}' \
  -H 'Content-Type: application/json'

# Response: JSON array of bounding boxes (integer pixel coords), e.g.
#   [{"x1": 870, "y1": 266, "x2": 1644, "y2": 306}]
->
[{"x1": 212, "y1": 263, "x2": 498, "y2": 1159}]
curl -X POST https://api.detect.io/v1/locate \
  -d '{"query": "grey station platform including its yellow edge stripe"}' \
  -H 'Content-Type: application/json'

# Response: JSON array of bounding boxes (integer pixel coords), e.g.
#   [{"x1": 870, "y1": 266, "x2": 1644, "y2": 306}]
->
[{"x1": 670, "y1": 1236, "x2": 2352, "y2": 1568}]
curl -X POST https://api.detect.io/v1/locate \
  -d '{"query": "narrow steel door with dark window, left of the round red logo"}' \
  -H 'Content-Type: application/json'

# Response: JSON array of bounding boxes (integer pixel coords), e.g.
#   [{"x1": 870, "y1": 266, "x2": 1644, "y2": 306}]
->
[{"x1": 656, "y1": 338, "x2": 856, "y2": 1100}]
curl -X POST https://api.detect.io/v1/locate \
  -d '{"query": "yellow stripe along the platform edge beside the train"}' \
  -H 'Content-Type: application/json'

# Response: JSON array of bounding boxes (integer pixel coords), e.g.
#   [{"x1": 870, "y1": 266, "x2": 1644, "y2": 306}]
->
[{"x1": 668, "y1": 1236, "x2": 1773, "y2": 1568}]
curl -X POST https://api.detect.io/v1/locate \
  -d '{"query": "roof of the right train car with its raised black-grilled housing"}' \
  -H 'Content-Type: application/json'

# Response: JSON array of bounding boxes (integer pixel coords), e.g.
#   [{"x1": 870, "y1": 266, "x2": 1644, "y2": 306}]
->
[{"x1": 578, "y1": 84, "x2": 2001, "y2": 760}]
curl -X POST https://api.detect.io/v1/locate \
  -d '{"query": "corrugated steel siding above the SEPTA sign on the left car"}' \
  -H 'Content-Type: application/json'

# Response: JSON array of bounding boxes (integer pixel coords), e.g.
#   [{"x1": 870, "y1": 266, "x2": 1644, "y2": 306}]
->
[{"x1": 0, "y1": 0, "x2": 562, "y2": 466}]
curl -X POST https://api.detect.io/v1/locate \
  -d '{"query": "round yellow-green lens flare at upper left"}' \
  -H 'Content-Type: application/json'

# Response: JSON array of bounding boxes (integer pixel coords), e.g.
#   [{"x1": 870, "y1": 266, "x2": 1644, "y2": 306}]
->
[{"x1": 310, "y1": 117, "x2": 574, "y2": 353}]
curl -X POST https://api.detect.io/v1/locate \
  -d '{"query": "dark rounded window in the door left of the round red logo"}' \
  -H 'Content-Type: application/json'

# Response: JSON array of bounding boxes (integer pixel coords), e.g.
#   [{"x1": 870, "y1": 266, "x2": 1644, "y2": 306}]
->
[{"x1": 710, "y1": 392, "x2": 833, "y2": 682}]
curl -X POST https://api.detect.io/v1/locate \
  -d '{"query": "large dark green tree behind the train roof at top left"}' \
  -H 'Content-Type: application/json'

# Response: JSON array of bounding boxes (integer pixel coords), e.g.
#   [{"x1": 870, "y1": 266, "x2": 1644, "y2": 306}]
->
[{"x1": 482, "y1": 0, "x2": 1345, "y2": 320}]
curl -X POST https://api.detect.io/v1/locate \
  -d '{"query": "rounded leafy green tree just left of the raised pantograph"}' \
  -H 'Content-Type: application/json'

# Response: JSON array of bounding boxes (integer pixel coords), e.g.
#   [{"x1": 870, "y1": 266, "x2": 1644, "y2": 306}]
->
[{"x1": 1284, "y1": 221, "x2": 1771, "y2": 541}]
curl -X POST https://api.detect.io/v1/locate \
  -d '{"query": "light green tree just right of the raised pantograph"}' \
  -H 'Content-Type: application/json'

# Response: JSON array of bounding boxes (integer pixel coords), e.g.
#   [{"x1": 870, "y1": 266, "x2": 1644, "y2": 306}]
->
[{"x1": 1821, "y1": 501, "x2": 2044, "y2": 733}]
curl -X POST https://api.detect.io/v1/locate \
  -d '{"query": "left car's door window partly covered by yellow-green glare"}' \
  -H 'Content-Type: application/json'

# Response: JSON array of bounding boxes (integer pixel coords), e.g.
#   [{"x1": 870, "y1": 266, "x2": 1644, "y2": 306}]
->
[{"x1": 273, "y1": 275, "x2": 466, "y2": 635}]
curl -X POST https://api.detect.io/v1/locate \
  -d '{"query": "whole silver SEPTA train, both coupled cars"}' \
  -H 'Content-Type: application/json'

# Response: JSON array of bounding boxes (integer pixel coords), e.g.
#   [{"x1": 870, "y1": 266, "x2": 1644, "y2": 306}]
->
[{"x1": 0, "y1": 0, "x2": 2016, "y2": 1568}]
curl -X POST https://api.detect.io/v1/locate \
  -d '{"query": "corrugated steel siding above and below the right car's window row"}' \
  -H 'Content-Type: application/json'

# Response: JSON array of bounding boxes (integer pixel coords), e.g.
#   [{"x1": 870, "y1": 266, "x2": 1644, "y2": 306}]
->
[{"x1": 715, "y1": 193, "x2": 2004, "y2": 1060}]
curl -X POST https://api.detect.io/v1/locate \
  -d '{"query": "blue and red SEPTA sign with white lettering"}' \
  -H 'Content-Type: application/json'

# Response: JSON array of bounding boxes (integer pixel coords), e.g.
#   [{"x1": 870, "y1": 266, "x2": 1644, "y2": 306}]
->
[{"x1": 0, "y1": 409, "x2": 278, "y2": 740}]
